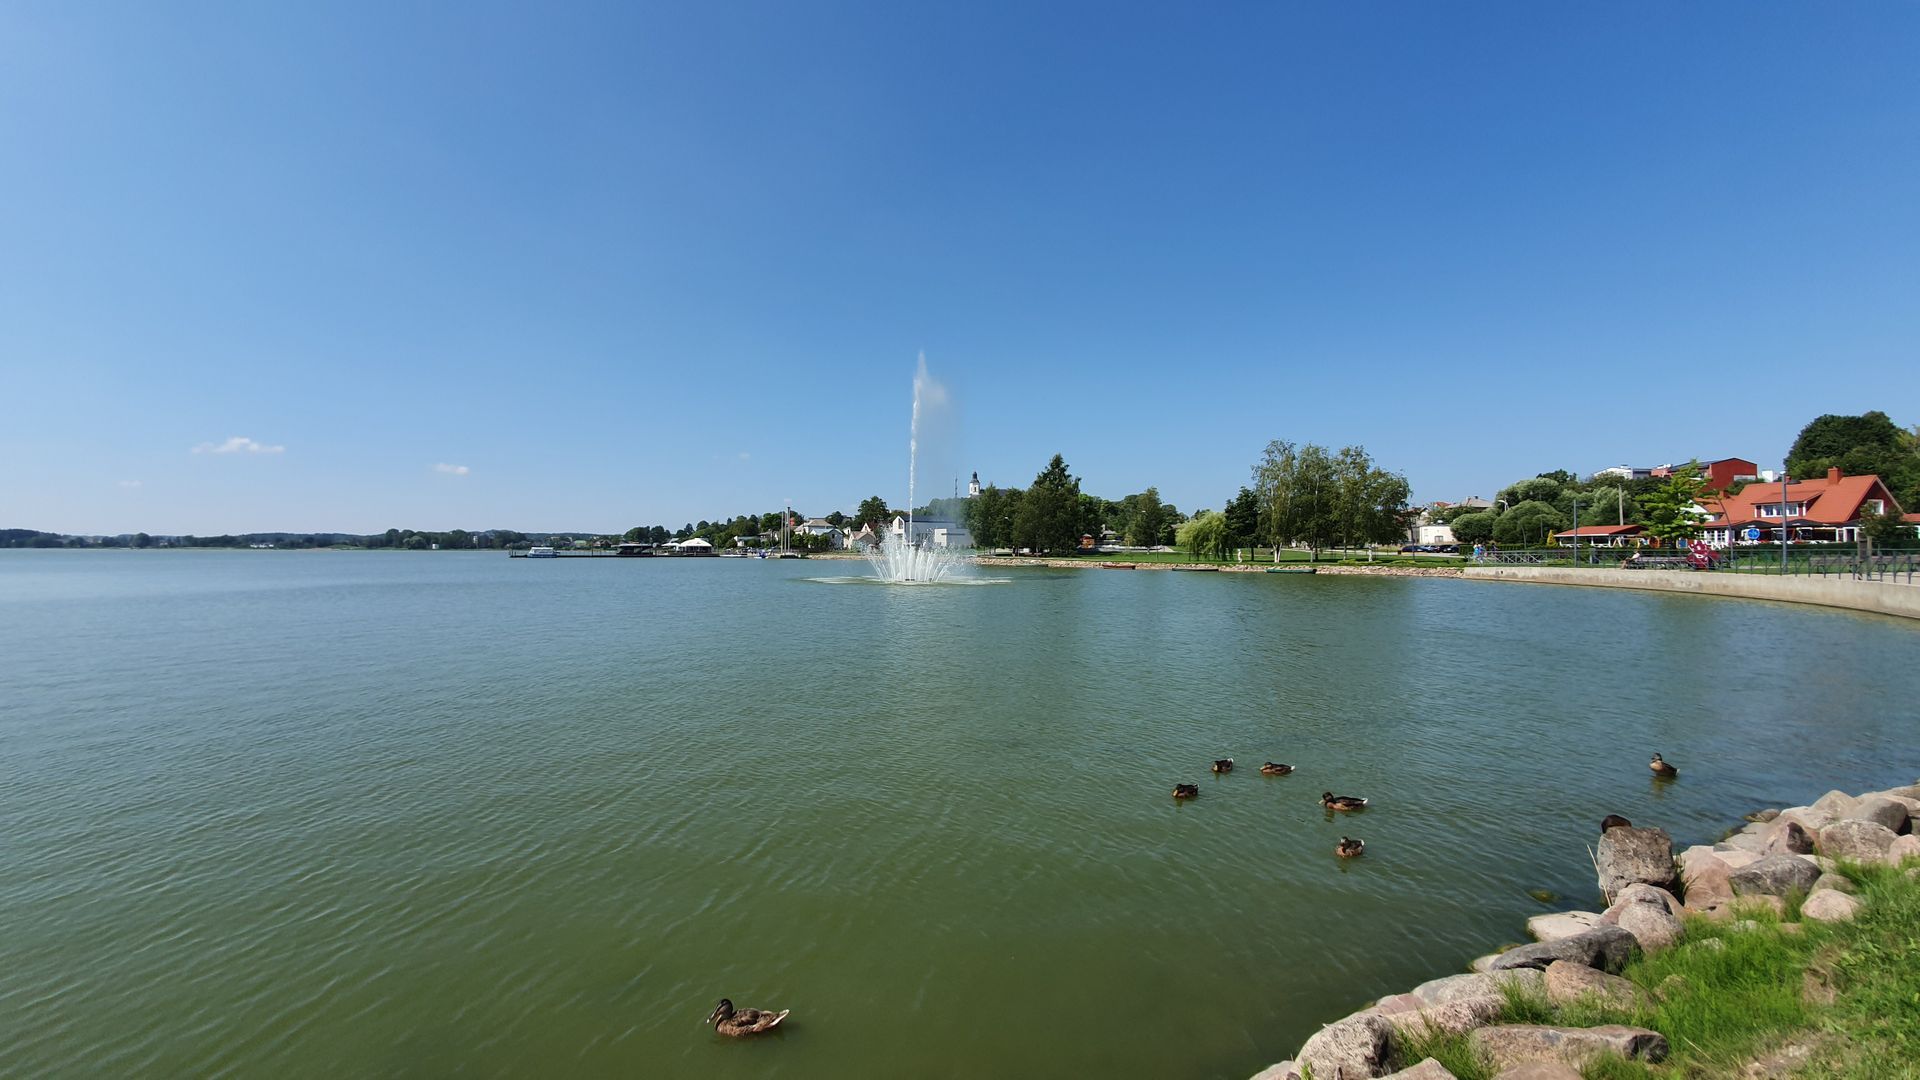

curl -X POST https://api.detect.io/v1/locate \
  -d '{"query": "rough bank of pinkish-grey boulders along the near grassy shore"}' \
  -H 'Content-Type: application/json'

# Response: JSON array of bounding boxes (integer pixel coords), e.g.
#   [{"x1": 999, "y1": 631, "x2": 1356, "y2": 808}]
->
[{"x1": 1254, "y1": 784, "x2": 1920, "y2": 1080}]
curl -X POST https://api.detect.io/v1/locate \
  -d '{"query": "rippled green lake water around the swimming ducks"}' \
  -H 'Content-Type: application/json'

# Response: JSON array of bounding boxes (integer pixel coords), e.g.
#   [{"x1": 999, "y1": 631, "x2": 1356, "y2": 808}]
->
[{"x1": 0, "y1": 552, "x2": 1920, "y2": 1078}]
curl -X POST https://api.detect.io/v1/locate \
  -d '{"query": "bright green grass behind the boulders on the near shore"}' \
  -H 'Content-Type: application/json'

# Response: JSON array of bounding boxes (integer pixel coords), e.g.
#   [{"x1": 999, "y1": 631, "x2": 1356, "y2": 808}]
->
[{"x1": 1404, "y1": 865, "x2": 1920, "y2": 1080}]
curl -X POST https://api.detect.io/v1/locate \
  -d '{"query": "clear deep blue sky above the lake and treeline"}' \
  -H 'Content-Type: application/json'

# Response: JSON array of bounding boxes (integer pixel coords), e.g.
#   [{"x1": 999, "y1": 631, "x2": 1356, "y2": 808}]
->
[{"x1": 0, "y1": 2, "x2": 1920, "y2": 534}]
